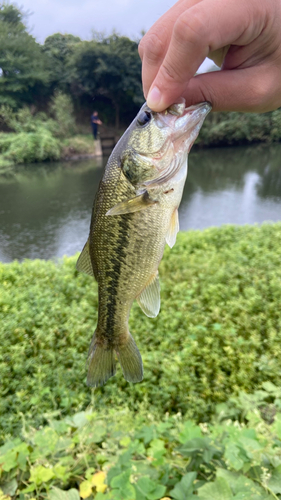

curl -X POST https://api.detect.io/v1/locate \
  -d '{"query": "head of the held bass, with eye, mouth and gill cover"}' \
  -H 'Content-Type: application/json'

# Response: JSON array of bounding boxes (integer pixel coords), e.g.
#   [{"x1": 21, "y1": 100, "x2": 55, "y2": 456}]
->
[{"x1": 120, "y1": 100, "x2": 211, "y2": 188}]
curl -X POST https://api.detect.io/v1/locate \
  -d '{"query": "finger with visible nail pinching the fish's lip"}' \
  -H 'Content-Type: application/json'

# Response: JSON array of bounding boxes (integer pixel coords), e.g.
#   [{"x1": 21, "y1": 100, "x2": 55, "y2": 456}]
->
[{"x1": 147, "y1": 0, "x2": 251, "y2": 111}]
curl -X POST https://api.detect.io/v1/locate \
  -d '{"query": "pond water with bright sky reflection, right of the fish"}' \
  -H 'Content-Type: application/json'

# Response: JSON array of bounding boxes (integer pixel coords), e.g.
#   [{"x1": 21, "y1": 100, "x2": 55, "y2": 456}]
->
[{"x1": 179, "y1": 144, "x2": 281, "y2": 230}]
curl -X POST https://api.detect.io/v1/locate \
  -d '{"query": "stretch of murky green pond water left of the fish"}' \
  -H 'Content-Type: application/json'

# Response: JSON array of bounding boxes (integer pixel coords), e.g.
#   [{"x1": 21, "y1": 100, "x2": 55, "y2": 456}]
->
[{"x1": 0, "y1": 160, "x2": 103, "y2": 262}]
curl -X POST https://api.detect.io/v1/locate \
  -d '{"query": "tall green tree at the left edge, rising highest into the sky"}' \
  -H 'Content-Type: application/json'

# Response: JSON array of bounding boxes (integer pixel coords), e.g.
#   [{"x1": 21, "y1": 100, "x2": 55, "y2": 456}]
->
[{"x1": 0, "y1": 3, "x2": 48, "y2": 108}]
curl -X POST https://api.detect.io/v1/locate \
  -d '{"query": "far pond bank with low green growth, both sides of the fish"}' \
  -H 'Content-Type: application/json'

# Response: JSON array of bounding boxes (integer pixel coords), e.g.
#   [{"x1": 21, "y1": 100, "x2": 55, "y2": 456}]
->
[{"x1": 0, "y1": 104, "x2": 281, "y2": 174}]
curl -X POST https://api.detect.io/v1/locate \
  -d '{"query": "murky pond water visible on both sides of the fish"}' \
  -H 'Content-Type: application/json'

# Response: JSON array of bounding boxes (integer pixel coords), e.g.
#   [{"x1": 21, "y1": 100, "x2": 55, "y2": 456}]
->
[{"x1": 0, "y1": 144, "x2": 281, "y2": 262}]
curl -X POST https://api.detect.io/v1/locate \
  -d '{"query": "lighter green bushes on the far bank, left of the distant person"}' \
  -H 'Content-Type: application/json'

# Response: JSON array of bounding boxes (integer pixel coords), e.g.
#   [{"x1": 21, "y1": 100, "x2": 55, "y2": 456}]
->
[{"x1": 0, "y1": 92, "x2": 93, "y2": 170}]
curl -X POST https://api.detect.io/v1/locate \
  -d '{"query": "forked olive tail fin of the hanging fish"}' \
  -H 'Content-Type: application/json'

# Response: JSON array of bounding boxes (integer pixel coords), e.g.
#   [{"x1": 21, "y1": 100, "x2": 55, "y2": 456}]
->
[{"x1": 87, "y1": 333, "x2": 143, "y2": 387}]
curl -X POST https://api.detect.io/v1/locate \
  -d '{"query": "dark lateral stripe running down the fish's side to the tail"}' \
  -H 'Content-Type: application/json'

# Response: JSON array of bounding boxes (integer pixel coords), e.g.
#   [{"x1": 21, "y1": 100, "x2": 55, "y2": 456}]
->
[{"x1": 104, "y1": 214, "x2": 133, "y2": 345}]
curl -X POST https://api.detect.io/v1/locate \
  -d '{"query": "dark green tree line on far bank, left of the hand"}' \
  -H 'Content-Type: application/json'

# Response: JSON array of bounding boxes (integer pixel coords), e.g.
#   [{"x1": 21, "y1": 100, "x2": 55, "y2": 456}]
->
[{"x1": 0, "y1": 3, "x2": 144, "y2": 127}]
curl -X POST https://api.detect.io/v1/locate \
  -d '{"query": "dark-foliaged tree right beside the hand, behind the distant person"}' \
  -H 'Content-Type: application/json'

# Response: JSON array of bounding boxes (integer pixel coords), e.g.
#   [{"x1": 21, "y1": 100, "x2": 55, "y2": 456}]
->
[{"x1": 69, "y1": 34, "x2": 143, "y2": 128}]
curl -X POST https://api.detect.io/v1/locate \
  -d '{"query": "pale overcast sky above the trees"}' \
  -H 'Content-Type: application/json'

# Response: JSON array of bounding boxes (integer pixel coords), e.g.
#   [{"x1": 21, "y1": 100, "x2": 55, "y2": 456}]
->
[{"x1": 18, "y1": 0, "x2": 212, "y2": 69}]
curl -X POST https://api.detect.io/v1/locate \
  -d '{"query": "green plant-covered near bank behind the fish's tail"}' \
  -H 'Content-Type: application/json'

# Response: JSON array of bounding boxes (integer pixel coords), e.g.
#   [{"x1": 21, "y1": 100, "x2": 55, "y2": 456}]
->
[{"x1": 0, "y1": 223, "x2": 281, "y2": 500}]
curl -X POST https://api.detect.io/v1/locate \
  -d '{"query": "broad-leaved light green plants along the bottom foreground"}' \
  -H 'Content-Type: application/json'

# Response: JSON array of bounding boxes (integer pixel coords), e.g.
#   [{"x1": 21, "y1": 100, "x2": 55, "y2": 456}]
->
[{"x1": 0, "y1": 383, "x2": 281, "y2": 500}]
